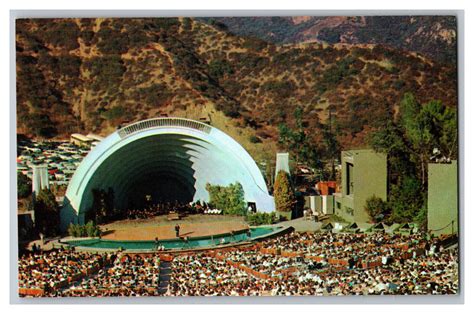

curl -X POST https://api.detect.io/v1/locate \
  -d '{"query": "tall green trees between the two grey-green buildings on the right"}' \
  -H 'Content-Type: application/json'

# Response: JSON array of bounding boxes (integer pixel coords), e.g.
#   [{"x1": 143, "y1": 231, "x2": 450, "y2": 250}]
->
[{"x1": 369, "y1": 93, "x2": 458, "y2": 227}]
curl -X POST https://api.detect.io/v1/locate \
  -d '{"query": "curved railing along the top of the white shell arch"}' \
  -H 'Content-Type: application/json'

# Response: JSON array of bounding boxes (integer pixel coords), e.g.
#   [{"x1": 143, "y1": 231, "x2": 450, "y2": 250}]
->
[{"x1": 118, "y1": 118, "x2": 212, "y2": 138}]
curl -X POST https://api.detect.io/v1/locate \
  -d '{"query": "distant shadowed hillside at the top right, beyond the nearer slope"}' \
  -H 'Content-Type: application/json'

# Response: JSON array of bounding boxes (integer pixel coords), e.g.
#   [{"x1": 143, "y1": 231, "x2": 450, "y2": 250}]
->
[{"x1": 201, "y1": 16, "x2": 457, "y2": 65}]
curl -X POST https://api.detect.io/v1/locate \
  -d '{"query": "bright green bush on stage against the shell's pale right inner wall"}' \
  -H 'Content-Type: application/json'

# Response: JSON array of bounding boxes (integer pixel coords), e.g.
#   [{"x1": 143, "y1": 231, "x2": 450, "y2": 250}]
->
[{"x1": 206, "y1": 182, "x2": 247, "y2": 215}]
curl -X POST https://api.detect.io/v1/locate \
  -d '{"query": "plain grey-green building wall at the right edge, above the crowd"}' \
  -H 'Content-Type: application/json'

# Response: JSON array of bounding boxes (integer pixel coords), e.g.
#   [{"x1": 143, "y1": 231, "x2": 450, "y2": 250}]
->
[{"x1": 428, "y1": 160, "x2": 459, "y2": 236}]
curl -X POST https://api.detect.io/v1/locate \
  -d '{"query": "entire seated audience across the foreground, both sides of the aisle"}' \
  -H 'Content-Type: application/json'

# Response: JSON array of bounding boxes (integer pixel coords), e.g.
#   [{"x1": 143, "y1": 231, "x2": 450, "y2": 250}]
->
[{"x1": 19, "y1": 232, "x2": 459, "y2": 296}]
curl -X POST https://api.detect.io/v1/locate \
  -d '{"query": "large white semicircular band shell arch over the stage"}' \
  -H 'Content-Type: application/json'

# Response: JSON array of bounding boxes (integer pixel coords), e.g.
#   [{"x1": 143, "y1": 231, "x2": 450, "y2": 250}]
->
[{"x1": 61, "y1": 118, "x2": 275, "y2": 229}]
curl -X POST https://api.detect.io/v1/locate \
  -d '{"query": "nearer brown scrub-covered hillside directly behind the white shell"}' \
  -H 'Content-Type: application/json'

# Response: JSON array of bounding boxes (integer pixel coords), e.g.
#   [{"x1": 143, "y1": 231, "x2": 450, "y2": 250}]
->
[{"x1": 16, "y1": 18, "x2": 457, "y2": 160}]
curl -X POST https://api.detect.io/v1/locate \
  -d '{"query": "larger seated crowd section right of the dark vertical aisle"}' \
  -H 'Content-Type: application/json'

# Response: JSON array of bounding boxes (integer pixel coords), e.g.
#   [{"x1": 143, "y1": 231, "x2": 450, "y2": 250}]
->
[{"x1": 165, "y1": 233, "x2": 459, "y2": 296}]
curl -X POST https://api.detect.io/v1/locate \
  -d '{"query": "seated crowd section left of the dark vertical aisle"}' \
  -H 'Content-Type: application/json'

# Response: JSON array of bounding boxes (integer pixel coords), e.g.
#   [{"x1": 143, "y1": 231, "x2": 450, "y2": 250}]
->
[{"x1": 18, "y1": 249, "x2": 160, "y2": 297}]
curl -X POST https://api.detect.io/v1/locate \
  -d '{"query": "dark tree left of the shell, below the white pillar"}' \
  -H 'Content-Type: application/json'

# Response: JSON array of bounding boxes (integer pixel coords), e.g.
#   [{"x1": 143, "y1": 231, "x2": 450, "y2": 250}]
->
[{"x1": 34, "y1": 189, "x2": 59, "y2": 235}]
